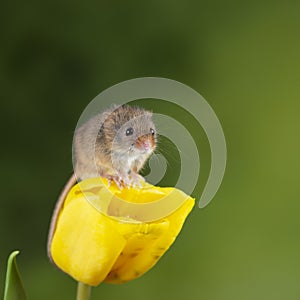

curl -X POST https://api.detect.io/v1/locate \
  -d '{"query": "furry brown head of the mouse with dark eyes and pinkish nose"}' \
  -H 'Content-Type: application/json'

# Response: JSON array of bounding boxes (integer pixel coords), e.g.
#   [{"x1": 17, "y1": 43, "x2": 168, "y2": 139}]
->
[{"x1": 103, "y1": 105, "x2": 157, "y2": 158}]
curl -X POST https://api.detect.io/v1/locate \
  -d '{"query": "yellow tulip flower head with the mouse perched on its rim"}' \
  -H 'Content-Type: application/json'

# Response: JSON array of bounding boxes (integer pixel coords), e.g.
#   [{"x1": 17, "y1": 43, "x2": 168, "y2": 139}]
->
[{"x1": 49, "y1": 178, "x2": 195, "y2": 286}]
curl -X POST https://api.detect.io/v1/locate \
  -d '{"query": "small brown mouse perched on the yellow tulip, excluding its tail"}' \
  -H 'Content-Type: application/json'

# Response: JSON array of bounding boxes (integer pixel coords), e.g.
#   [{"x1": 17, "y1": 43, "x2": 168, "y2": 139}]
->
[{"x1": 74, "y1": 105, "x2": 156, "y2": 187}]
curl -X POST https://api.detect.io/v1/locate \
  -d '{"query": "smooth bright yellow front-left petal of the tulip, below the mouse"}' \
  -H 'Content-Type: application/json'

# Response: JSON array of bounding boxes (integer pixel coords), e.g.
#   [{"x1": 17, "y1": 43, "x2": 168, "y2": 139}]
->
[{"x1": 51, "y1": 193, "x2": 126, "y2": 285}]
